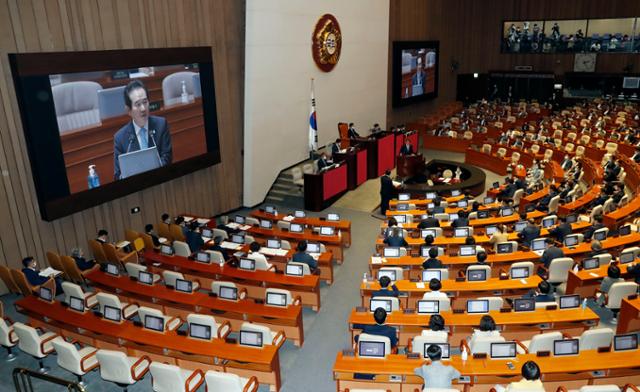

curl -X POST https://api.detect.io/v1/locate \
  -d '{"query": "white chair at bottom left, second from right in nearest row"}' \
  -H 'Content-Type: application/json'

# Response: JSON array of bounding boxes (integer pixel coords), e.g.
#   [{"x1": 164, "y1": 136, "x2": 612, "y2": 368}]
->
[{"x1": 149, "y1": 362, "x2": 204, "y2": 392}]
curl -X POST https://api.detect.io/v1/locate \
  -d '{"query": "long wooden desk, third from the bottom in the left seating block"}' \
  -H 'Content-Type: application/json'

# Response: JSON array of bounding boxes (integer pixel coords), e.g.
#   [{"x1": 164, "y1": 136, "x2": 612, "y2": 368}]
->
[{"x1": 144, "y1": 251, "x2": 320, "y2": 311}]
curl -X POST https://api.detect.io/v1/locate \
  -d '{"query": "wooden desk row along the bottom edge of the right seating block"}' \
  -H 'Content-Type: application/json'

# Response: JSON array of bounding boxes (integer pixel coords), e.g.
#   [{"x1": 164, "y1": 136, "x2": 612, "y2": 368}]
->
[{"x1": 333, "y1": 350, "x2": 640, "y2": 392}]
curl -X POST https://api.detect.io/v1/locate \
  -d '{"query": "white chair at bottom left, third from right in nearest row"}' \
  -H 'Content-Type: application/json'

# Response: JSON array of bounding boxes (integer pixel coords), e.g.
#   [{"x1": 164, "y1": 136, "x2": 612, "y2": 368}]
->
[{"x1": 96, "y1": 350, "x2": 151, "y2": 391}]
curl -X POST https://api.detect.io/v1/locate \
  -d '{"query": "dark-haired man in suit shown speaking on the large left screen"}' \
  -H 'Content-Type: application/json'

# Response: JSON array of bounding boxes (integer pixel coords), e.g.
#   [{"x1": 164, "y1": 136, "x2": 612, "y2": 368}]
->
[{"x1": 113, "y1": 80, "x2": 172, "y2": 180}]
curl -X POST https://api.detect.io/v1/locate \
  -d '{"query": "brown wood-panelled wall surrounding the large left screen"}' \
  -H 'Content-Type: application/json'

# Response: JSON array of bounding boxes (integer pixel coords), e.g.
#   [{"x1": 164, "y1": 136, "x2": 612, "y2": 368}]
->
[{"x1": 0, "y1": 0, "x2": 245, "y2": 267}]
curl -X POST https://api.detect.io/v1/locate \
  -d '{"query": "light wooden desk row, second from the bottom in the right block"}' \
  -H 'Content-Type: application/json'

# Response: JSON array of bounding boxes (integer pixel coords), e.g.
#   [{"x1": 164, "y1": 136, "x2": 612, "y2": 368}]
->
[{"x1": 349, "y1": 307, "x2": 599, "y2": 346}]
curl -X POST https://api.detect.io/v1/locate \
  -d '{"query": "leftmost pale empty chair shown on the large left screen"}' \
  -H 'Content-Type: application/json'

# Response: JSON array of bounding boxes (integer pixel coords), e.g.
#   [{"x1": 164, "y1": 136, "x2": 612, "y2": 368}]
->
[{"x1": 51, "y1": 81, "x2": 102, "y2": 133}]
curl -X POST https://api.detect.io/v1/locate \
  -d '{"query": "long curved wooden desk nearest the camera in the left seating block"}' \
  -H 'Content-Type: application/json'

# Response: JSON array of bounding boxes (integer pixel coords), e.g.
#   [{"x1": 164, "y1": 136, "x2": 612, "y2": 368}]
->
[{"x1": 15, "y1": 296, "x2": 284, "y2": 390}]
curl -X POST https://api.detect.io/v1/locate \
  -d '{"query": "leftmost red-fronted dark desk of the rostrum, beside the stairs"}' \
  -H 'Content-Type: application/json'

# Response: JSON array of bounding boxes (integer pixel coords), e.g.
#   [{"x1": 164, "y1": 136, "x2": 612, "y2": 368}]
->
[{"x1": 304, "y1": 164, "x2": 347, "y2": 211}]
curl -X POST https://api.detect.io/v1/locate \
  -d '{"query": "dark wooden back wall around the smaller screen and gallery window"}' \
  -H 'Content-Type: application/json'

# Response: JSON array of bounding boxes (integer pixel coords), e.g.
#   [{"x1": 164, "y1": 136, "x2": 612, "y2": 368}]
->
[{"x1": 387, "y1": 0, "x2": 640, "y2": 125}]
